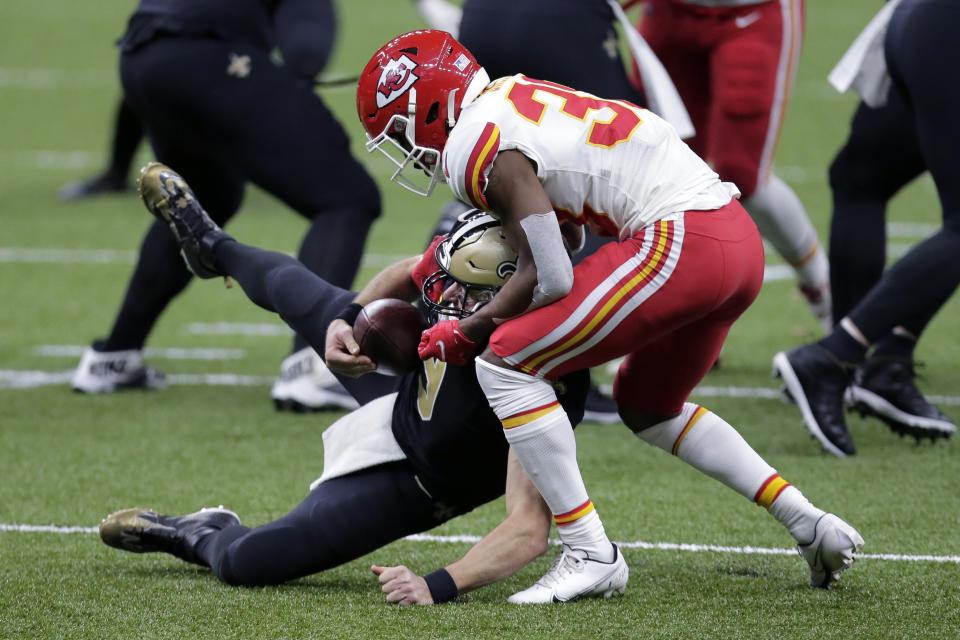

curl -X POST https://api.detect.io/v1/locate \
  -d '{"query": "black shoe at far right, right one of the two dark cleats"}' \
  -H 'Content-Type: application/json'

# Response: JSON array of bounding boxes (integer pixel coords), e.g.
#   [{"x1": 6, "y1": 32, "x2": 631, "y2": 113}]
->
[{"x1": 847, "y1": 357, "x2": 957, "y2": 442}]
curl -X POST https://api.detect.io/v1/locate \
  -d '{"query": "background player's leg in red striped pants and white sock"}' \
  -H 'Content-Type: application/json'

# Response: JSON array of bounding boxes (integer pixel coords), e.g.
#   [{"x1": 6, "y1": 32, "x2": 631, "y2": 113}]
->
[{"x1": 707, "y1": 0, "x2": 831, "y2": 329}]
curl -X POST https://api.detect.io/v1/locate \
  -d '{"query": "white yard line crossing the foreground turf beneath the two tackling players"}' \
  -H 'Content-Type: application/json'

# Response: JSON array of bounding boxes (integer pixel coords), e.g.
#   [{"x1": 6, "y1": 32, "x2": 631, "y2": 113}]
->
[{"x1": 0, "y1": 523, "x2": 960, "y2": 564}]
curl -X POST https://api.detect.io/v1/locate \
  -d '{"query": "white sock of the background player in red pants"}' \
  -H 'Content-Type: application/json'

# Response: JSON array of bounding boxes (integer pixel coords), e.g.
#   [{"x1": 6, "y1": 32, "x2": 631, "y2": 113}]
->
[{"x1": 743, "y1": 174, "x2": 830, "y2": 290}]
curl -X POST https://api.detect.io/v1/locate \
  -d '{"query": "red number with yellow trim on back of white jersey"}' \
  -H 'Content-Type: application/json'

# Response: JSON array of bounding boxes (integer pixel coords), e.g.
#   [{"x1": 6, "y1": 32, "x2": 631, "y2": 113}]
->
[{"x1": 507, "y1": 82, "x2": 643, "y2": 149}]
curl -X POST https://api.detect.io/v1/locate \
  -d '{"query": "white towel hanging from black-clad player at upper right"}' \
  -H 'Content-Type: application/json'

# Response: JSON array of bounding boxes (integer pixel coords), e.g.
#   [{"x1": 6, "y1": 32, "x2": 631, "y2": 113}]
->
[{"x1": 827, "y1": 0, "x2": 900, "y2": 108}]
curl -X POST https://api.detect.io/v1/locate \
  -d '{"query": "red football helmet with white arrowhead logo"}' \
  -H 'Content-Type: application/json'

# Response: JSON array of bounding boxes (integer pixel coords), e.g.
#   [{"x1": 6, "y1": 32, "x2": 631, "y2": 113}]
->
[{"x1": 357, "y1": 30, "x2": 490, "y2": 196}]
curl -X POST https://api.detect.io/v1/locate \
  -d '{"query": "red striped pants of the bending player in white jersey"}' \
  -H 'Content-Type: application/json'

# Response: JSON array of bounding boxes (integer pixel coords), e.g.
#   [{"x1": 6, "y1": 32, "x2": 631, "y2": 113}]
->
[{"x1": 490, "y1": 200, "x2": 763, "y2": 413}]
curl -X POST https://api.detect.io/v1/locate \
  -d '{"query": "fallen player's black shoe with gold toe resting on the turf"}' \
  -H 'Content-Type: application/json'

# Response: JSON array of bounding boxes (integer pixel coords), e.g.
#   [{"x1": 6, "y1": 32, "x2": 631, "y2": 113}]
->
[{"x1": 100, "y1": 505, "x2": 240, "y2": 564}]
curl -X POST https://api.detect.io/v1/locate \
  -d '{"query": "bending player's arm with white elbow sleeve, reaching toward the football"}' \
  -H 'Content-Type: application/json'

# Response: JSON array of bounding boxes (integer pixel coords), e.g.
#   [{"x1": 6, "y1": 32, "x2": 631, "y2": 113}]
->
[{"x1": 460, "y1": 150, "x2": 573, "y2": 342}]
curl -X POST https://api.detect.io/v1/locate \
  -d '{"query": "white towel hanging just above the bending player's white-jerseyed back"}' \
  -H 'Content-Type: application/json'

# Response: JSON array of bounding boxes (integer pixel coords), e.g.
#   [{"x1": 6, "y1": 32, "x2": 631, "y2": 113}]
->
[{"x1": 603, "y1": 0, "x2": 696, "y2": 138}]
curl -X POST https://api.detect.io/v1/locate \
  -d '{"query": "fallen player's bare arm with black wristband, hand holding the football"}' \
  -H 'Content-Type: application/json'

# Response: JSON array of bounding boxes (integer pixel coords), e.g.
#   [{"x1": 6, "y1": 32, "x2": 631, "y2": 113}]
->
[{"x1": 324, "y1": 256, "x2": 421, "y2": 376}]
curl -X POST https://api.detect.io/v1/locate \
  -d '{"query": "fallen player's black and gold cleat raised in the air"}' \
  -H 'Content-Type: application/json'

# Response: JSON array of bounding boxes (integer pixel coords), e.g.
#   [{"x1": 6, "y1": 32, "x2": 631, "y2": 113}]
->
[{"x1": 137, "y1": 162, "x2": 233, "y2": 278}]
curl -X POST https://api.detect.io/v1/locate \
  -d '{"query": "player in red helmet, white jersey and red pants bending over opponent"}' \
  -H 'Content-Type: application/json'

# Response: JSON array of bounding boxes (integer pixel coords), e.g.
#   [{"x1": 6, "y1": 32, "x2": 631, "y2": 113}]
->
[{"x1": 352, "y1": 31, "x2": 863, "y2": 602}]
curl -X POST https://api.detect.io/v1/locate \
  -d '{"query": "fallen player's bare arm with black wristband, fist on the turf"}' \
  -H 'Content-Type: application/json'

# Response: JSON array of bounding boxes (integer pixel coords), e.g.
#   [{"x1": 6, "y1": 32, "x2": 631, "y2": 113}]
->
[{"x1": 371, "y1": 451, "x2": 551, "y2": 604}]
